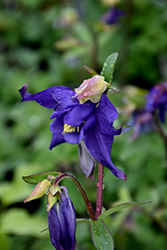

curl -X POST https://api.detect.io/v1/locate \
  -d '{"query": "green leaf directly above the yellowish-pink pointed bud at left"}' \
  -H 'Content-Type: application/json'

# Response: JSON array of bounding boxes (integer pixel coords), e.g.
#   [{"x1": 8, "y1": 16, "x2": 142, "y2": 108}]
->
[{"x1": 22, "y1": 171, "x2": 60, "y2": 184}]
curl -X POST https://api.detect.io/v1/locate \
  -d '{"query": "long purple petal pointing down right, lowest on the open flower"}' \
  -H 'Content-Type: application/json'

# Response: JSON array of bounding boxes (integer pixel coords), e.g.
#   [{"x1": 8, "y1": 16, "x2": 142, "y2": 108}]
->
[{"x1": 84, "y1": 125, "x2": 127, "y2": 180}]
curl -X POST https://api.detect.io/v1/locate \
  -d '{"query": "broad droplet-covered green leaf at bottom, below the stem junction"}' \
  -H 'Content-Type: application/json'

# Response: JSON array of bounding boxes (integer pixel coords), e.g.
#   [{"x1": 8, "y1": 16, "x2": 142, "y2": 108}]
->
[{"x1": 89, "y1": 219, "x2": 114, "y2": 250}]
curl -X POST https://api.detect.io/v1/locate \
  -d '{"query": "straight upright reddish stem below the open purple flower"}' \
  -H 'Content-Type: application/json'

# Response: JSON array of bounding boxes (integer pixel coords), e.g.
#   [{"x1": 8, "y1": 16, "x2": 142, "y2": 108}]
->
[{"x1": 96, "y1": 163, "x2": 104, "y2": 219}]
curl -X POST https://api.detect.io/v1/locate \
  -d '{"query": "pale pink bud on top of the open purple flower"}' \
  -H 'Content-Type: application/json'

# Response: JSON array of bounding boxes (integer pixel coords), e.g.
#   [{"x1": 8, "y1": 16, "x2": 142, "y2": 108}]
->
[{"x1": 74, "y1": 75, "x2": 110, "y2": 104}]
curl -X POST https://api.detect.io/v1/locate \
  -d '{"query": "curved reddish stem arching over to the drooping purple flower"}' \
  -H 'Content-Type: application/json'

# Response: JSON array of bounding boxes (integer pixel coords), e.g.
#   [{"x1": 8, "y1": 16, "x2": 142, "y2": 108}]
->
[{"x1": 55, "y1": 173, "x2": 96, "y2": 221}]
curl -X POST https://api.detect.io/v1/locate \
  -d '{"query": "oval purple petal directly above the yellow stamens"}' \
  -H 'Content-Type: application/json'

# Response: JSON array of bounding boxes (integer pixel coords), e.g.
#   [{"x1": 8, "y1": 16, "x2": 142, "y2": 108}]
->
[{"x1": 64, "y1": 102, "x2": 95, "y2": 127}]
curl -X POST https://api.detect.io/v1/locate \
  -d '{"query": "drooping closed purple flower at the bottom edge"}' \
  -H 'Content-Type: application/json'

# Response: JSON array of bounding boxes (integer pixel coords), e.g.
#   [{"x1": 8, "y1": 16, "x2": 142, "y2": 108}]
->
[{"x1": 48, "y1": 187, "x2": 76, "y2": 250}]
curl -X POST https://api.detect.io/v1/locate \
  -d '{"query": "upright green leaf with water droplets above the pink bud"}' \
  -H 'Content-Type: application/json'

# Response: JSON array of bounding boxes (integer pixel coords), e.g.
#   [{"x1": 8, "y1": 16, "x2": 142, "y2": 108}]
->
[{"x1": 101, "y1": 53, "x2": 118, "y2": 83}]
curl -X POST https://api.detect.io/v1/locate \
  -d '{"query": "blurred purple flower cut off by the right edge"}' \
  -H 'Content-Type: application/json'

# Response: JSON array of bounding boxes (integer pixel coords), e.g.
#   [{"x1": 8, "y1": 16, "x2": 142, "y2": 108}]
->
[{"x1": 146, "y1": 82, "x2": 167, "y2": 123}]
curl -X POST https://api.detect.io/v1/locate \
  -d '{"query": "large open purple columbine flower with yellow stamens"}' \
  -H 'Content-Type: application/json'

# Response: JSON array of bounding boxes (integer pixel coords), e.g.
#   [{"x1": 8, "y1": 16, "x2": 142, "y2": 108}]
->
[{"x1": 19, "y1": 85, "x2": 126, "y2": 180}]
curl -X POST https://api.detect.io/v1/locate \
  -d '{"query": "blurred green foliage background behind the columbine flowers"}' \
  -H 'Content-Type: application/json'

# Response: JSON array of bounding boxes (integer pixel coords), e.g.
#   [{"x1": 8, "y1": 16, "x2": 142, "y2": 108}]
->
[{"x1": 0, "y1": 0, "x2": 167, "y2": 250}]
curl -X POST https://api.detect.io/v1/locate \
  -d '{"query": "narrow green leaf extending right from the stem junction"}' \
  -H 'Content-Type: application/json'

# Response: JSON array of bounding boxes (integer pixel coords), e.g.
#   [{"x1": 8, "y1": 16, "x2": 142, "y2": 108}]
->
[{"x1": 98, "y1": 201, "x2": 151, "y2": 219}]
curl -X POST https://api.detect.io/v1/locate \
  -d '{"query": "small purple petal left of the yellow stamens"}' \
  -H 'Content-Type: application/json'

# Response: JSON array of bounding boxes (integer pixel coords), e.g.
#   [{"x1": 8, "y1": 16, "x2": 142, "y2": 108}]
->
[{"x1": 49, "y1": 116, "x2": 65, "y2": 149}]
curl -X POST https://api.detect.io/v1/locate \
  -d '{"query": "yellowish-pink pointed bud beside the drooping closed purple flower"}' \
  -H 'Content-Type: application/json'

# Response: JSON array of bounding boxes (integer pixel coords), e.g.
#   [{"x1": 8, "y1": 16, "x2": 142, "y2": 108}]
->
[{"x1": 24, "y1": 179, "x2": 51, "y2": 202}]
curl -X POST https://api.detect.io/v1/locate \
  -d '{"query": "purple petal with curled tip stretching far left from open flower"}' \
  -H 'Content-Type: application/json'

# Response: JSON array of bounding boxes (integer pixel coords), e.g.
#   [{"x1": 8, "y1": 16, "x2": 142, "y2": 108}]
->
[{"x1": 19, "y1": 84, "x2": 67, "y2": 109}]
